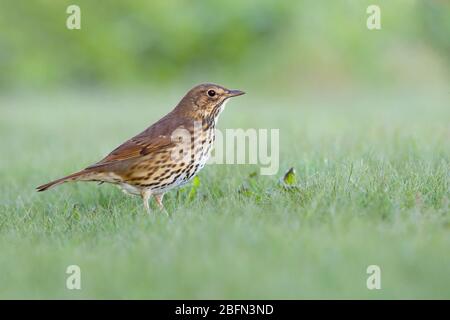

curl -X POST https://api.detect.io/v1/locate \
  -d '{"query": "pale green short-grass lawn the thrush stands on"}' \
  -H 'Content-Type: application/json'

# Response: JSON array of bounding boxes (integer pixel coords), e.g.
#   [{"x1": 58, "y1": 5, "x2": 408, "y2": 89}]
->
[{"x1": 0, "y1": 89, "x2": 450, "y2": 299}]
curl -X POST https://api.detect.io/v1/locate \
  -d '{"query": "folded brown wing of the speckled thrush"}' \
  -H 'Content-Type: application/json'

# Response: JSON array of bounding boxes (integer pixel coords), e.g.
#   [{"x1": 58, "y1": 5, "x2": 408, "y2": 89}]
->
[{"x1": 86, "y1": 116, "x2": 191, "y2": 169}]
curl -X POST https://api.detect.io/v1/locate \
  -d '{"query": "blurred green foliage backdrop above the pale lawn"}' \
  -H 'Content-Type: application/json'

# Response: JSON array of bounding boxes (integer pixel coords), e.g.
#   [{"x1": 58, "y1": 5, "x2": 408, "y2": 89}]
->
[{"x1": 0, "y1": 0, "x2": 450, "y2": 90}]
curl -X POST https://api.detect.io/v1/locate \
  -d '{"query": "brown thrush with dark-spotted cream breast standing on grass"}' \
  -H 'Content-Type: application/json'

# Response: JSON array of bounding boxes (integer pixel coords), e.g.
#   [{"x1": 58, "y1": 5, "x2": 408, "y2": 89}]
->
[{"x1": 36, "y1": 83, "x2": 245, "y2": 213}]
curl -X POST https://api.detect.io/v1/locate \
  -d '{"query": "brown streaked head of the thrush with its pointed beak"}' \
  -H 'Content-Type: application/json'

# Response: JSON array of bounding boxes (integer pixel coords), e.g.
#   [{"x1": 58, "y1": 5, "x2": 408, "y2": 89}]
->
[{"x1": 176, "y1": 83, "x2": 245, "y2": 119}]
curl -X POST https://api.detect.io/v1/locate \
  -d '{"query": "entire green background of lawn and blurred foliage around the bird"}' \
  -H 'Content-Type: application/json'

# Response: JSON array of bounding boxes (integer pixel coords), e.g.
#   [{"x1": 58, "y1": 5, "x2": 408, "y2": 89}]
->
[{"x1": 0, "y1": 0, "x2": 450, "y2": 299}]
